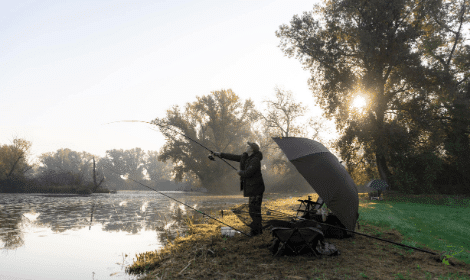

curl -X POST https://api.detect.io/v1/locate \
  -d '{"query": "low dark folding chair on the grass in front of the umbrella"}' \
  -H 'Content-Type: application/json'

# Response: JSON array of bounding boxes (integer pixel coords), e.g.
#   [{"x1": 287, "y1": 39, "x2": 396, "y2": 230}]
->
[{"x1": 271, "y1": 227, "x2": 323, "y2": 257}]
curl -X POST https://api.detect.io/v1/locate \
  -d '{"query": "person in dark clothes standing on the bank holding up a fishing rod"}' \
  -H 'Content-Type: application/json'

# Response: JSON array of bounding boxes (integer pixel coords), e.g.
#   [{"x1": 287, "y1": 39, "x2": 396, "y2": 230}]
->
[{"x1": 214, "y1": 142, "x2": 264, "y2": 236}]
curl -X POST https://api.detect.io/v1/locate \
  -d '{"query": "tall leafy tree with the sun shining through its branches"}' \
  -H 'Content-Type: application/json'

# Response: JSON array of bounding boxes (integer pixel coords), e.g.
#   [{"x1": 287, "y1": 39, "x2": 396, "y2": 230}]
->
[{"x1": 276, "y1": 0, "x2": 436, "y2": 188}]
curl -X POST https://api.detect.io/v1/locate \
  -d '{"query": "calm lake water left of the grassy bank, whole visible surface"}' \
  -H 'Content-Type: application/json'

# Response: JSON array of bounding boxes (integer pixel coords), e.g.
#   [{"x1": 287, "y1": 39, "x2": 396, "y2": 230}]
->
[{"x1": 0, "y1": 191, "x2": 247, "y2": 280}]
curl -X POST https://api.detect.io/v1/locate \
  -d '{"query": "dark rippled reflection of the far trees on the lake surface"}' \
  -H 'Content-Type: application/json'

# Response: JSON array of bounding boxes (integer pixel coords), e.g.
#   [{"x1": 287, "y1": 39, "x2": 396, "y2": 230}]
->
[{"x1": 0, "y1": 193, "x2": 244, "y2": 250}]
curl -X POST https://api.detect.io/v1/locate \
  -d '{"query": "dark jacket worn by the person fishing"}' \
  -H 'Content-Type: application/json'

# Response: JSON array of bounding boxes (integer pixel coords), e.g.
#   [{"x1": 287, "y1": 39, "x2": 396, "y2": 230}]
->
[{"x1": 220, "y1": 152, "x2": 264, "y2": 197}]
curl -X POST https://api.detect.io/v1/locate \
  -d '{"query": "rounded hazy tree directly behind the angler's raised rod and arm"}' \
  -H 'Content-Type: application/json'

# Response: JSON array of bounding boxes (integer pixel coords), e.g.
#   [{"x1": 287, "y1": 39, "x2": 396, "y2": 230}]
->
[{"x1": 153, "y1": 89, "x2": 257, "y2": 191}]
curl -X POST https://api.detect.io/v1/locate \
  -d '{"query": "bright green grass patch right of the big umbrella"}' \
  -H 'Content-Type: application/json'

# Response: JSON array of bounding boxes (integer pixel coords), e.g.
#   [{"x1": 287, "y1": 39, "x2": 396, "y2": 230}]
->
[{"x1": 359, "y1": 199, "x2": 470, "y2": 264}]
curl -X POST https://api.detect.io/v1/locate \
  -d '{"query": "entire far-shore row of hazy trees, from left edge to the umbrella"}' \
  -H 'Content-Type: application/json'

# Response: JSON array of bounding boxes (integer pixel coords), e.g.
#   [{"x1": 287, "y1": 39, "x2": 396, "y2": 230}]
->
[{"x1": 0, "y1": 87, "x2": 321, "y2": 193}]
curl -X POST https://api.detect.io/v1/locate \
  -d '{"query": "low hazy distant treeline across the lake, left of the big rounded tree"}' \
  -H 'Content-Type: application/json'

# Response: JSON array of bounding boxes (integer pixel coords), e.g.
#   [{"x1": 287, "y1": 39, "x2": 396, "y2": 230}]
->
[{"x1": 0, "y1": 142, "x2": 191, "y2": 194}]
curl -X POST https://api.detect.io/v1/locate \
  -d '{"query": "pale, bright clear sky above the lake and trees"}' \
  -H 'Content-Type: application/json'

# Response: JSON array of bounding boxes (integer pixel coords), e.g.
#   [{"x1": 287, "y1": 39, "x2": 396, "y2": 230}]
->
[{"x1": 0, "y1": 0, "x2": 336, "y2": 161}]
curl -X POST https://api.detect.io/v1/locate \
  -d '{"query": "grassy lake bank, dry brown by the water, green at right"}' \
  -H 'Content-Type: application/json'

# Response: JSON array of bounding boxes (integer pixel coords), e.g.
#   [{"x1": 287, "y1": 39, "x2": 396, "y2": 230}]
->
[{"x1": 128, "y1": 194, "x2": 470, "y2": 279}]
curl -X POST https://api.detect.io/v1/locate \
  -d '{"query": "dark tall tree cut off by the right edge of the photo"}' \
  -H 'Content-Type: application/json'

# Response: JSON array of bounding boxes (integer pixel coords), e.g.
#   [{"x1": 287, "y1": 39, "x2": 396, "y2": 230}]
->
[{"x1": 419, "y1": 0, "x2": 470, "y2": 192}]
